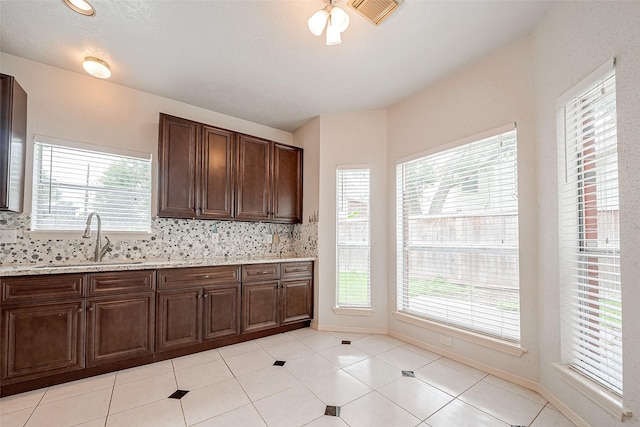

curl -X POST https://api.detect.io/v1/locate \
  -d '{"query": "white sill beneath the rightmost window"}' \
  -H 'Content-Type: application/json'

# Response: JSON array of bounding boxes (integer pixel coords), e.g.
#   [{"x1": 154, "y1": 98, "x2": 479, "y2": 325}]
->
[{"x1": 553, "y1": 363, "x2": 632, "y2": 421}]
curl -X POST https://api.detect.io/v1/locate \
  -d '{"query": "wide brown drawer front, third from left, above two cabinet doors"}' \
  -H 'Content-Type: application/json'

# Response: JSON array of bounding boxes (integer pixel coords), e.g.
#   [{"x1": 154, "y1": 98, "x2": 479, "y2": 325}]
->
[{"x1": 158, "y1": 266, "x2": 240, "y2": 289}]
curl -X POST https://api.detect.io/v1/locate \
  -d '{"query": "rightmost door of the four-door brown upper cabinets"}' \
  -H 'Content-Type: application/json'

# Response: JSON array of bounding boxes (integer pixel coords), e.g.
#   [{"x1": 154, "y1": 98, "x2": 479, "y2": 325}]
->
[{"x1": 272, "y1": 144, "x2": 302, "y2": 223}]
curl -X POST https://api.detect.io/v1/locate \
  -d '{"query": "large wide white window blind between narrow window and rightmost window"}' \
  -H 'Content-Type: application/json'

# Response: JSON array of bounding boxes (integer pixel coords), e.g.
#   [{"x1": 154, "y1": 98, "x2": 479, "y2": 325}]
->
[{"x1": 397, "y1": 129, "x2": 520, "y2": 342}]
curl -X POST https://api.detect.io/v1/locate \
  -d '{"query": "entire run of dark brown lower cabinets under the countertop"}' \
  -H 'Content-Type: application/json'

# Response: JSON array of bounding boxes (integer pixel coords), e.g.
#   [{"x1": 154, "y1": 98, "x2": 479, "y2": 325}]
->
[{"x1": 0, "y1": 262, "x2": 313, "y2": 396}]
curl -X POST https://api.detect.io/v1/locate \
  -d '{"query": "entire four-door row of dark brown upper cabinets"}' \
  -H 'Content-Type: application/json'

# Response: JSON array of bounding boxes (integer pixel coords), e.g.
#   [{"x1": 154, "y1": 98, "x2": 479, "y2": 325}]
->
[{"x1": 158, "y1": 113, "x2": 302, "y2": 227}]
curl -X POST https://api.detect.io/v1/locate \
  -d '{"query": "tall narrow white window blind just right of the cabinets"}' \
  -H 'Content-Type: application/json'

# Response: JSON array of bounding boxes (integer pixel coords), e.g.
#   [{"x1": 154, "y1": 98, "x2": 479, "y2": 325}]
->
[{"x1": 336, "y1": 168, "x2": 371, "y2": 307}]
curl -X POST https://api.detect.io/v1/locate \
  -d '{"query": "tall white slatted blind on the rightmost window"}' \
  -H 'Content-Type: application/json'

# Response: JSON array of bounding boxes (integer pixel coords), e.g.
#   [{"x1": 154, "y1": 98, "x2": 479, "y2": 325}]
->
[{"x1": 559, "y1": 66, "x2": 622, "y2": 395}]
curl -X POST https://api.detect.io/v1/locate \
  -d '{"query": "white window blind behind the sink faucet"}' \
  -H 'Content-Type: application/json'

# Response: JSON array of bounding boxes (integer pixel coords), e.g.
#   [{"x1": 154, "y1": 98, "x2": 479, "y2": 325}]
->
[{"x1": 31, "y1": 140, "x2": 151, "y2": 232}]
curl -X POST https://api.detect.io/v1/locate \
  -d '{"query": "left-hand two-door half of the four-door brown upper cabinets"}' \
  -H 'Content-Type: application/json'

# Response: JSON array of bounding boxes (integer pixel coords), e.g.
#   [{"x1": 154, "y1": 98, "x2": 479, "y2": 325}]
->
[{"x1": 158, "y1": 113, "x2": 235, "y2": 219}]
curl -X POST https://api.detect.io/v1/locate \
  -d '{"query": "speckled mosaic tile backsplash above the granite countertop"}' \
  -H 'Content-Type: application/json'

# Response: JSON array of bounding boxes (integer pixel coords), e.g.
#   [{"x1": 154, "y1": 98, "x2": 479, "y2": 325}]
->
[{"x1": 0, "y1": 212, "x2": 318, "y2": 266}]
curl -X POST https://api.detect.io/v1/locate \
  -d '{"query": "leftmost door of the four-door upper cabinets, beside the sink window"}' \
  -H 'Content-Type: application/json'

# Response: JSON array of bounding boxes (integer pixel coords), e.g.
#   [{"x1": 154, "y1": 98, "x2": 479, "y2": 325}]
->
[{"x1": 158, "y1": 114, "x2": 199, "y2": 218}]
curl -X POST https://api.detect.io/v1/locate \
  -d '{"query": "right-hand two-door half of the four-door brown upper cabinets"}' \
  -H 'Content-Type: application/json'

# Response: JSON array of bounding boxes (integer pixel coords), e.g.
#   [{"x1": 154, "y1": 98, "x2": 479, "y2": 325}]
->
[{"x1": 236, "y1": 135, "x2": 302, "y2": 223}]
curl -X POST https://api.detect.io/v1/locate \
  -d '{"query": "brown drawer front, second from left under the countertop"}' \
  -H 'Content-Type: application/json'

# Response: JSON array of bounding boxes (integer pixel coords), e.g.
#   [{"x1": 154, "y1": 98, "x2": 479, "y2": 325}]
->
[{"x1": 88, "y1": 270, "x2": 155, "y2": 296}]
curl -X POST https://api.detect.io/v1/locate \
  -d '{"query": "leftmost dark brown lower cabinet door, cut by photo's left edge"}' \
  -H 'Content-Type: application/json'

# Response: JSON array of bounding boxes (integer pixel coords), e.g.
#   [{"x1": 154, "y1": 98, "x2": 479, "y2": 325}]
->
[{"x1": 1, "y1": 299, "x2": 85, "y2": 381}]
